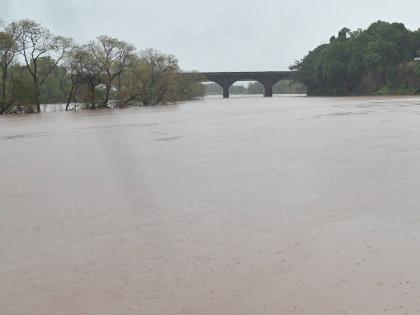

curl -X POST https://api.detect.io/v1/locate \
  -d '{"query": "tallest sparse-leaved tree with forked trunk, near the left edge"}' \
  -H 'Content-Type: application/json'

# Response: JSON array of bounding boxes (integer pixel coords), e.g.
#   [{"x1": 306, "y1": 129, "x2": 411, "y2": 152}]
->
[{"x1": 11, "y1": 20, "x2": 71, "y2": 112}]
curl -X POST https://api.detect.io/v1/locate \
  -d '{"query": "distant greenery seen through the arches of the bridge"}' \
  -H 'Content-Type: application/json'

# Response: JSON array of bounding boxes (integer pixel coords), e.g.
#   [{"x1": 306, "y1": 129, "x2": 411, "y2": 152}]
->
[{"x1": 205, "y1": 80, "x2": 306, "y2": 95}]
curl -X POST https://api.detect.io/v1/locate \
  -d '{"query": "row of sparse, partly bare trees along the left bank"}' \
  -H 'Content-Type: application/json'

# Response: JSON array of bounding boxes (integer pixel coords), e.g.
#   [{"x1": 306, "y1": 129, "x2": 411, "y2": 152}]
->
[{"x1": 0, "y1": 20, "x2": 204, "y2": 114}]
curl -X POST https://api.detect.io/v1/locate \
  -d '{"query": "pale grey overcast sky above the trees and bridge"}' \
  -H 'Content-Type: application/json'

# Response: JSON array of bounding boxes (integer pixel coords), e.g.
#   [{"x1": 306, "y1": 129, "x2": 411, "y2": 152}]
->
[{"x1": 0, "y1": 0, "x2": 420, "y2": 71}]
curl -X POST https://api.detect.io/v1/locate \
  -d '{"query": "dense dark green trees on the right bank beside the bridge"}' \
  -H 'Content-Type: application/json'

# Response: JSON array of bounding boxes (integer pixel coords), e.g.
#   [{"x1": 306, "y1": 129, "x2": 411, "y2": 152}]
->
[{"x1": 291, "y1": 21, "x2": 420, "y2": 95}]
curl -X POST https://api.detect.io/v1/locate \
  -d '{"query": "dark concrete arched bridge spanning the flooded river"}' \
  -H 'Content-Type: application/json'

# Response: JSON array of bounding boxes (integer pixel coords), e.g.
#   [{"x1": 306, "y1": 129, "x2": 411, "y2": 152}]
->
[{"x1": 197, "y1": 71, "x2": 294, "y2": 98}]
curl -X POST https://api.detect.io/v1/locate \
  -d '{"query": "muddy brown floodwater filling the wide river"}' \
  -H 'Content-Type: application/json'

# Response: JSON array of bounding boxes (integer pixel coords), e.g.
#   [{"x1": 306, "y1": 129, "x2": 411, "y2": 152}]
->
[{"x1": 0, "y1": 96, "x2": 420, "y2": 315}]
